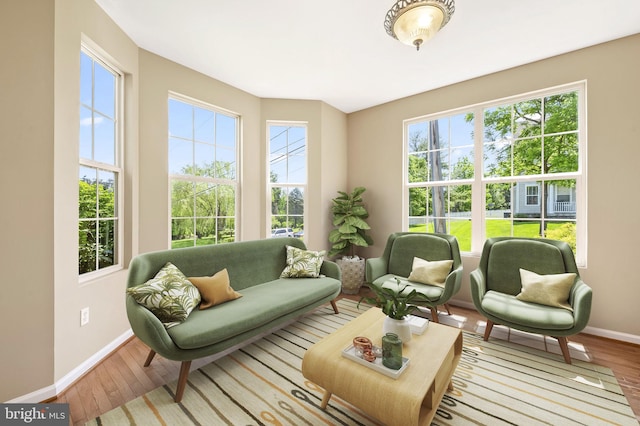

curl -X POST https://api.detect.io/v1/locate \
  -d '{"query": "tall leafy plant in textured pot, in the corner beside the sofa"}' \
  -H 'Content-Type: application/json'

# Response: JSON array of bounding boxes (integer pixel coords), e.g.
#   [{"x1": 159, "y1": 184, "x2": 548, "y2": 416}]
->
[{"x1": 328, "y1": 186, "x2": 373, "y2": 294}]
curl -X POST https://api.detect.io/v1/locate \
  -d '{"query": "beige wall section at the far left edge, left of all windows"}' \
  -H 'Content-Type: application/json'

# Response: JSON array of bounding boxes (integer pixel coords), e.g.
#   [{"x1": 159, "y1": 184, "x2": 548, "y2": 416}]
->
[{"x1": 0, "y1": 0, "x2": 54, "y2": 401}]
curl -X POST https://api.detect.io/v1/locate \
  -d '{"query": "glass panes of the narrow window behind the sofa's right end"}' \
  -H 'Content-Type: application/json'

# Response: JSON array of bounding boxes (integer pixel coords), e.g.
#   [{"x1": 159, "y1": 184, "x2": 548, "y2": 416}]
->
[{"x1": 267, "y1": 123, "x2": 307, "y2": 237}]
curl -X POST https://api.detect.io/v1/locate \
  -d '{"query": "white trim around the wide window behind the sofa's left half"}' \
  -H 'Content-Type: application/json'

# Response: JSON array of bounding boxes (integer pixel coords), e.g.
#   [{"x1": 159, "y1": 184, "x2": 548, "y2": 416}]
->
[{"x1": 166, "y1": 90, "x2": 242, "y2": 249}]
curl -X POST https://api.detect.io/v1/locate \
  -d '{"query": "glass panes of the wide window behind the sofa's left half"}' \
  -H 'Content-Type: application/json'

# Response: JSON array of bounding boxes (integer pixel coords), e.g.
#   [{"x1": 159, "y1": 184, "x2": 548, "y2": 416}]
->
[{"x1": 169, "y1": 95, "x2": 240, "y2": 248}]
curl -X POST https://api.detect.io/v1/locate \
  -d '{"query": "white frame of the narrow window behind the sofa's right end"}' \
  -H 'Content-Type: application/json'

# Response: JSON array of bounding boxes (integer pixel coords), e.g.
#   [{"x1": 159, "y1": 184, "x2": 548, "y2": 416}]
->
[{"x1": 265, "y1": 120, "x2": 309, "y2": 241}]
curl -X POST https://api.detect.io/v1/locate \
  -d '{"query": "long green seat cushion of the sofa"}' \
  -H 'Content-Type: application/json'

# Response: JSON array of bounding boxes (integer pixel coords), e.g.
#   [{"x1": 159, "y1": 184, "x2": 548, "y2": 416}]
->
[{"x1": 167, "y1": 278, "x2": 340, "y2": 349}]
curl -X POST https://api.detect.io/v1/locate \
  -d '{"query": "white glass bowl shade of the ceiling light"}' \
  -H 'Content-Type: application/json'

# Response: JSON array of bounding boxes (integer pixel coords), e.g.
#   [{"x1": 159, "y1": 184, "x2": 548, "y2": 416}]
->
[{"x1": 393, "y1": 5, "x2": 444, "y2": 49}]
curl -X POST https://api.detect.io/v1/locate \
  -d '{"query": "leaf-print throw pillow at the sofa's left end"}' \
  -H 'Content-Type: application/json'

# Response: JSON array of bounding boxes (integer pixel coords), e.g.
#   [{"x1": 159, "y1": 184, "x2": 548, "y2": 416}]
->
[{"x1": 127, "y1": 262, "x2": 200, "y2": 328}]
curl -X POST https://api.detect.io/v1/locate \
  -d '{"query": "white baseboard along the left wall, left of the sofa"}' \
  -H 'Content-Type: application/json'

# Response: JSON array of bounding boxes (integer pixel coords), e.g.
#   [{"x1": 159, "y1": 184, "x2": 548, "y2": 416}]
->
[{"x1": 6, "y1": 329, "x2": 133, "y2": 404}]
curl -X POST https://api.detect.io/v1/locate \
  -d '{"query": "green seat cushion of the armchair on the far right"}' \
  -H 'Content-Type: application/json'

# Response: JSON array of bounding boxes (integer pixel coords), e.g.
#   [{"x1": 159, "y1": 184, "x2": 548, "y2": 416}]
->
[{"x1": 482, "y1": 290, "x2": 574, "y2": 331}]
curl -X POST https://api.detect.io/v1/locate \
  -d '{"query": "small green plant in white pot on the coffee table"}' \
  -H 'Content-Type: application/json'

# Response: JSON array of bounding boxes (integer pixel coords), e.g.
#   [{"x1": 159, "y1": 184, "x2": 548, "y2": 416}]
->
[{"x1": 358, "y1": 278, "x2": 428, "y2": 342}]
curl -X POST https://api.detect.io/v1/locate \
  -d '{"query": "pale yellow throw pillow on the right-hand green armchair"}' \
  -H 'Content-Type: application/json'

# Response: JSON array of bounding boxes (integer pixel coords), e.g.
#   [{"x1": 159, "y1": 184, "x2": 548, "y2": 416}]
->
[{"x1": 516, "y1": 269, "x2": 576, "y2": 311}]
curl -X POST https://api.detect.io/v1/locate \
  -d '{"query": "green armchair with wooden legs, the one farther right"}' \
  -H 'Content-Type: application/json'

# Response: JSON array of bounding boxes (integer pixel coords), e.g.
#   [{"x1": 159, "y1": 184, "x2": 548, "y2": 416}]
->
[{"x1": 470, "y1": 237, "x2": 592, "y2": 364}]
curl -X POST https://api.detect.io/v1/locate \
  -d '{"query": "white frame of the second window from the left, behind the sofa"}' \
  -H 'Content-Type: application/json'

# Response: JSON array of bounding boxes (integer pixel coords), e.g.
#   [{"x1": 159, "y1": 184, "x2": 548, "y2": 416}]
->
[{"x1": 167, "y1": 91, "x2": 242, "y2": 249}]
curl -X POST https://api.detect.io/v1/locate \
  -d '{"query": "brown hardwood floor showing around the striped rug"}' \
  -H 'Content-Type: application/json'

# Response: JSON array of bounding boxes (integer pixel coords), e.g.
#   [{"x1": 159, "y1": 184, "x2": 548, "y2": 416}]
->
[{"x1": 49, "y1": 296, "x2": 640, "y2": 425}]
